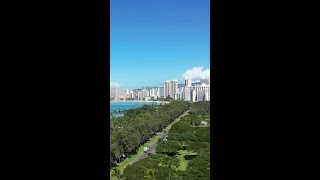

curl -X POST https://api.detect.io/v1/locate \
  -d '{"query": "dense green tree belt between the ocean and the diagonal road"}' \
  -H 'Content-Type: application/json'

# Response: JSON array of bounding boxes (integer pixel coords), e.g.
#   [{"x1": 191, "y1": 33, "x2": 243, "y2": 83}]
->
[{"x1": 110, "y1": 101, "x2": 190, "y2": 166}]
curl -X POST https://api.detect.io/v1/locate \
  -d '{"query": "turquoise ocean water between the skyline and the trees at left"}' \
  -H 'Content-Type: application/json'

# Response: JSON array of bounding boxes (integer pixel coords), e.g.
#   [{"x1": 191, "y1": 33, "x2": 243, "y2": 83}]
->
[{"x1": 110, "y1": 101, "x2": 159, "y2": 112}]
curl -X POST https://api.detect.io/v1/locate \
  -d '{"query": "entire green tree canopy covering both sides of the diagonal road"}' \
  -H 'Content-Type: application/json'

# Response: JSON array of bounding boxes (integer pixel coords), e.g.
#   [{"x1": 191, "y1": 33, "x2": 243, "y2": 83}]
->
[{"x1": 110, "y1": 101, "x2": 210, "y2": 180}]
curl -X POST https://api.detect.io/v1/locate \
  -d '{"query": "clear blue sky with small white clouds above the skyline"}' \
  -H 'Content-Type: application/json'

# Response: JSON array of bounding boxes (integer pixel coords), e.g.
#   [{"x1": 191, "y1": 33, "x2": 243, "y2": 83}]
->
[{"x1": 110, "y1": 0, "x2": 210, "y2": 88}]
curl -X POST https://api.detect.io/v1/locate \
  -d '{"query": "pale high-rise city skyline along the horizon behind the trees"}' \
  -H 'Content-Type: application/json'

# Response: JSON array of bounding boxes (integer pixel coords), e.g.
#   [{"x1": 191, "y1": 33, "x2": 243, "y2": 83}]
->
[{"x1": 110, "y1": 79, "x2": 210, "y2": 102}]
